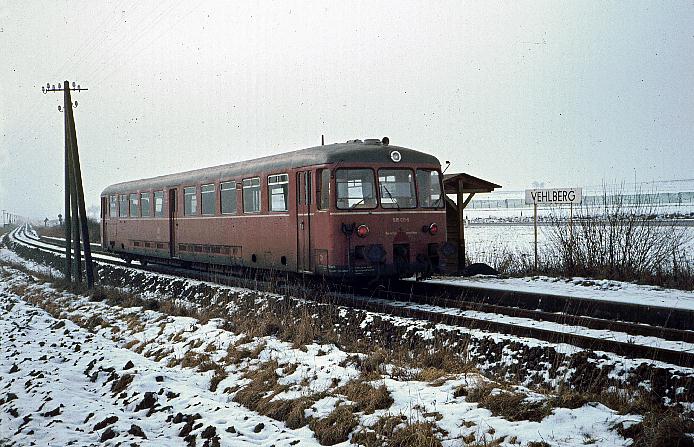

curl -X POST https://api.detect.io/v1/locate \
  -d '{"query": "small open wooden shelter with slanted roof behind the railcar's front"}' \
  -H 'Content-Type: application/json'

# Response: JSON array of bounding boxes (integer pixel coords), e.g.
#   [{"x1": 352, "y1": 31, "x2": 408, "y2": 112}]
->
[{"x1": 443, "y1": 172, "x2": 501, "y2": 273}]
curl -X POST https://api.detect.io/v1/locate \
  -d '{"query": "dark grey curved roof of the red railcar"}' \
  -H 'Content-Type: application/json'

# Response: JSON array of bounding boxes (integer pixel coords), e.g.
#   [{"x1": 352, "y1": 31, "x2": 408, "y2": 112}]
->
[{"x1": 101, "y1": 142, "x2": 440, "y2": 195}]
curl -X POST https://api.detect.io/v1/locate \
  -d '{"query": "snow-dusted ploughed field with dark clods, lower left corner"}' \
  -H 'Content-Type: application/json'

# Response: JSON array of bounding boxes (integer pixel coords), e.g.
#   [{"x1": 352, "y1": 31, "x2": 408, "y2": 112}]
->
[{"x1": 0, "y1": 269, "x2": 315, "y2": 446}]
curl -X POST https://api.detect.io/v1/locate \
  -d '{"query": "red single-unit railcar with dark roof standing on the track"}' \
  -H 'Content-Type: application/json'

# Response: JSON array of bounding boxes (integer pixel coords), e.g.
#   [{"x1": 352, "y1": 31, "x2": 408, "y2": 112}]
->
[{"x1": 101, "y1": 139, "x2": 455, "y2": 277}]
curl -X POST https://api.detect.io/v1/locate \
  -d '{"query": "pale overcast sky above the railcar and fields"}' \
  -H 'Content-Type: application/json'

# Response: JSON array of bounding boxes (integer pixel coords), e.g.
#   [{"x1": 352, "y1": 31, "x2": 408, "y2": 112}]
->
[{"x1": 0, "y1": 0, "x2": 694, "y2": 217}]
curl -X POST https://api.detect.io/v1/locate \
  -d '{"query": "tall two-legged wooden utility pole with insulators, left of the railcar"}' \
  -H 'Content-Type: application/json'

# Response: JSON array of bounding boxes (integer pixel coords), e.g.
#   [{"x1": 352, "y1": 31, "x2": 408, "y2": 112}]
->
[{"x1": 41, "y1": 81, "x2": 94, "y2": 289}]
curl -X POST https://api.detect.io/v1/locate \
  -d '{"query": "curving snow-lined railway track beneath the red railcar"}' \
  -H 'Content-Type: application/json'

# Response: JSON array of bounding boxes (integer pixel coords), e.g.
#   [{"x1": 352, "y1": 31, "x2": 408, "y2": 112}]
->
[{"x1": 5, "y1": 228, "x2": 694, "y2": 367}]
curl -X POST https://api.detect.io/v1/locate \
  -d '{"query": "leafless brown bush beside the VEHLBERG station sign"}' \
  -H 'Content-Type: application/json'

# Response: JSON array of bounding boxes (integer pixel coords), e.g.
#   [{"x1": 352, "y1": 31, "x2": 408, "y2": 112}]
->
[{"x1": 544, "y1": 188, "x2": 694, "y2": 289}]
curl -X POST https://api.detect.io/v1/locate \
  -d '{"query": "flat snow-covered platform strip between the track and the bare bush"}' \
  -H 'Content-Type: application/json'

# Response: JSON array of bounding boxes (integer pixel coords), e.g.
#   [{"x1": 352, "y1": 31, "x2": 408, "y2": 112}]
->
[{"x1": 429, "y1": 276, "x2": 694, "y2": 310}]
